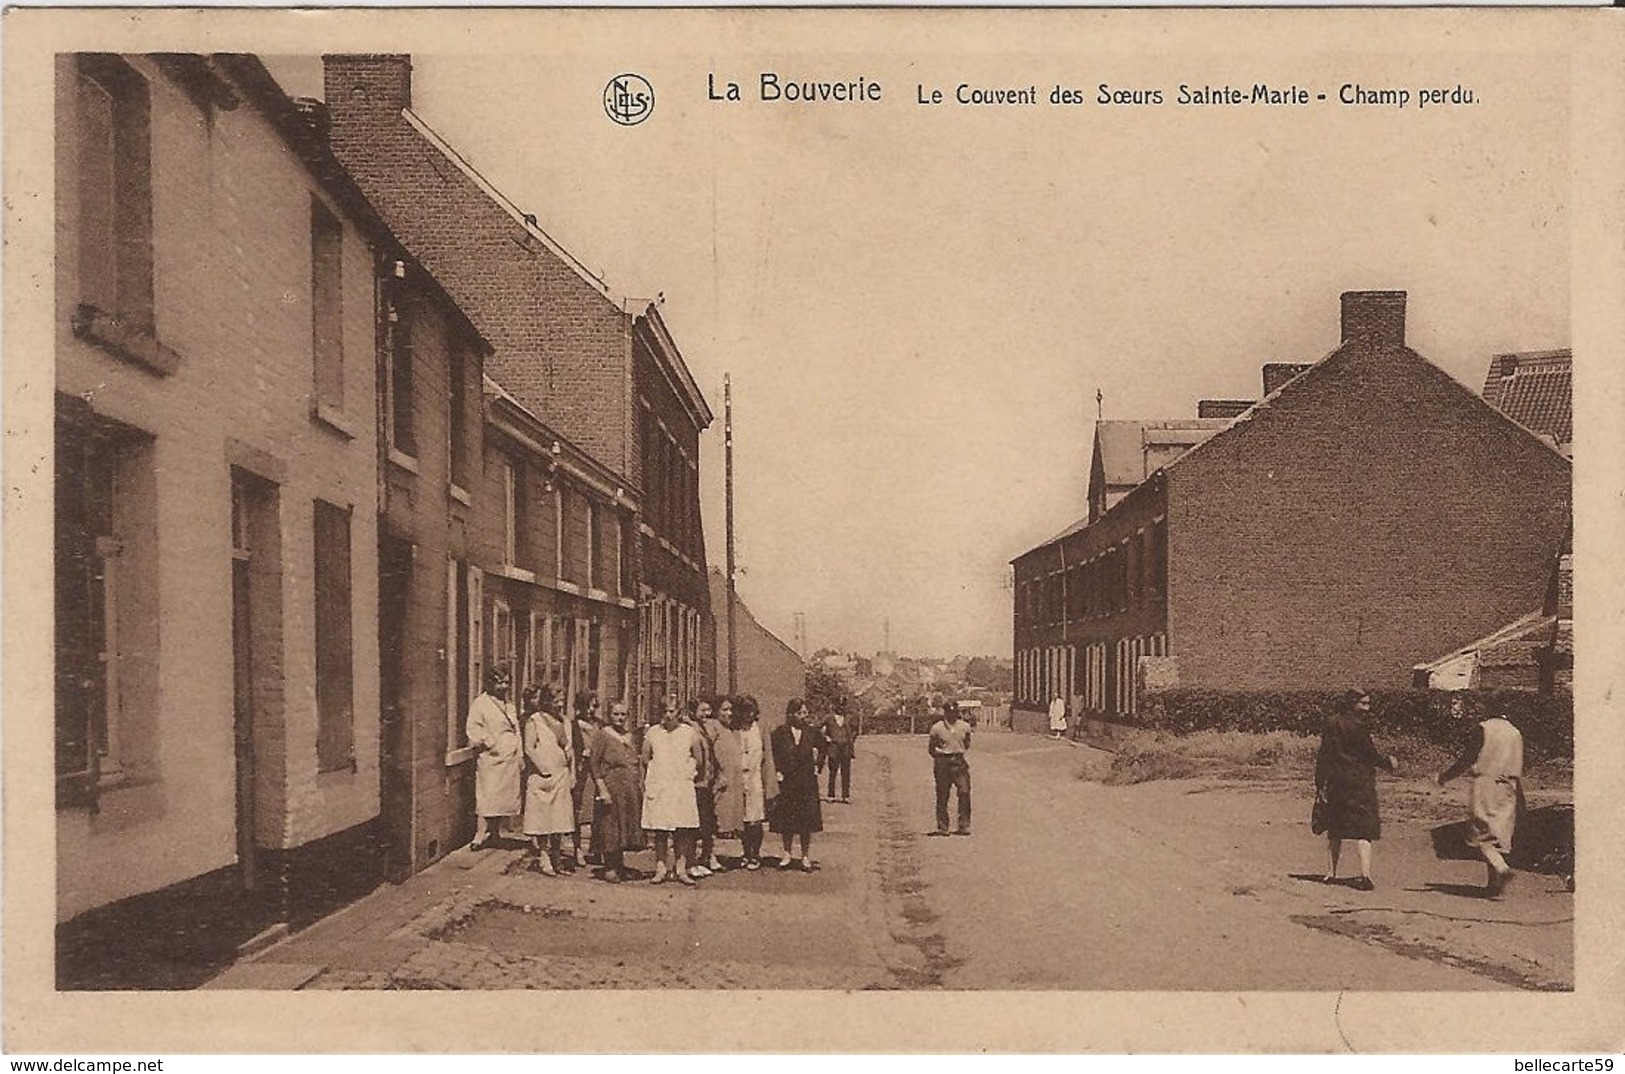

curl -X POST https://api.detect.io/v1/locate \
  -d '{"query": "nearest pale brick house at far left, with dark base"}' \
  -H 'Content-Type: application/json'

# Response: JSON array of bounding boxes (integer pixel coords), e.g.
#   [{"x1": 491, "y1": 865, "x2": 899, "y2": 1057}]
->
[{"x1": 55, "y1": 54, "x2": 406, "y2": 986}]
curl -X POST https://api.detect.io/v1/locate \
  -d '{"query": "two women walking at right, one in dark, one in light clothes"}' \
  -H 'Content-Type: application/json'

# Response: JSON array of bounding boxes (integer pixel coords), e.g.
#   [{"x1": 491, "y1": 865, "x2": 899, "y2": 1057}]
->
[{"x1": 1310, "y1": 691, "x2": 1523, "y2": 899}]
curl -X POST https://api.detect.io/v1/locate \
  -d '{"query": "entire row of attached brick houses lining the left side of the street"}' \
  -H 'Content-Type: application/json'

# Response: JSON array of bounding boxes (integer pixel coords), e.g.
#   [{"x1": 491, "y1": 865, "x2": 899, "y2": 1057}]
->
[{"x1": 55, "y1": 54, "x2": 712, "y2": 988}]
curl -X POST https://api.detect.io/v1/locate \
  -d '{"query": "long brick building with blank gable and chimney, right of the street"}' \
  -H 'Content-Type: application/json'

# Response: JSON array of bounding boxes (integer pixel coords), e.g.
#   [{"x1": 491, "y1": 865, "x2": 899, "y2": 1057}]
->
[{"x1": 1014, "y1": 292, "x2": 1571, "y2": 713}]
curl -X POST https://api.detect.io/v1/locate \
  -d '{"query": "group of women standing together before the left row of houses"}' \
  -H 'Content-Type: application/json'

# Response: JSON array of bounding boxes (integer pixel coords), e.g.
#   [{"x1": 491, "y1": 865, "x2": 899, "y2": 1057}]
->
[{"x1": 468, "y1": 665, "x2": 824, "y2": 886}]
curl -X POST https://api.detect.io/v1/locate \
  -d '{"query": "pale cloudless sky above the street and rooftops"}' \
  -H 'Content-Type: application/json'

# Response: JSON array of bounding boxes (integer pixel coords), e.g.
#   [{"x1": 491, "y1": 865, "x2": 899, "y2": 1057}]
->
[{"x1": 270, "y1": 25, "x2": 1570, "y2": 656}]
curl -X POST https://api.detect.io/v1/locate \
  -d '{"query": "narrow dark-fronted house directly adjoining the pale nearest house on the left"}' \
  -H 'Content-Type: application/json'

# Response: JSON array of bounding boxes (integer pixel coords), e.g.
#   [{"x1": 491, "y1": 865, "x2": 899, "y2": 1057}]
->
[{"x1": 375, "y1": 252, "x2": 499, "y2": 881}]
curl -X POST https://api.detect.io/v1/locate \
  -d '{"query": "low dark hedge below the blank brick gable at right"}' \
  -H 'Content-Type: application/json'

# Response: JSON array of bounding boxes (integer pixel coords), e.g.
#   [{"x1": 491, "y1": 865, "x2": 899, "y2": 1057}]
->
[{"x1": 1131, "y1": 689, "x2": 1575, "y2": 759}]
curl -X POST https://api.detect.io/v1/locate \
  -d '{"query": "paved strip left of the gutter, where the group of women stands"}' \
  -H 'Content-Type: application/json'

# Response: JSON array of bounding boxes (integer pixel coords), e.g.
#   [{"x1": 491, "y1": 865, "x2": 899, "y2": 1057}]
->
[{"x1": 205, "y1": 778, "x2": 895, "y2": 990}]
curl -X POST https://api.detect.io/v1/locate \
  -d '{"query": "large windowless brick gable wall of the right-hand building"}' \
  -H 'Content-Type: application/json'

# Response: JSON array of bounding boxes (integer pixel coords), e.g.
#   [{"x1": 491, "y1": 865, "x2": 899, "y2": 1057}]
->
[{"x1": 1168, "y1": 339, "x2": 1570, "y2": 689}]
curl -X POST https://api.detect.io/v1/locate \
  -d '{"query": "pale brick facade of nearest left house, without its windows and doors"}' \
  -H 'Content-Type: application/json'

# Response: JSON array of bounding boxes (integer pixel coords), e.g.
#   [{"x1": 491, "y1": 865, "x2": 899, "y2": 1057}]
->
[{"x1": 55, "y1": 57, "x2": 379, "y2": 918}]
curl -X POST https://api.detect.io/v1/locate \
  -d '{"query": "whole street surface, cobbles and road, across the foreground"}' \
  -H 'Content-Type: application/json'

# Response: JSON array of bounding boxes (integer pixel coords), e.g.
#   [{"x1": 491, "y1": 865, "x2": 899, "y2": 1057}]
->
[{"x1": 208, "y1": 734, "x2": 1573, "y2": 991}]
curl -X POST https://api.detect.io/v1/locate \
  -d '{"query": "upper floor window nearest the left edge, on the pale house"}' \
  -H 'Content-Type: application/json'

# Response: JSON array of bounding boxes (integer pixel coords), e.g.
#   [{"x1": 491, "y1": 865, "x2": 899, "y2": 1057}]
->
[{"x1": 75, "y1": 55, "x2": 153, "y2": 331}]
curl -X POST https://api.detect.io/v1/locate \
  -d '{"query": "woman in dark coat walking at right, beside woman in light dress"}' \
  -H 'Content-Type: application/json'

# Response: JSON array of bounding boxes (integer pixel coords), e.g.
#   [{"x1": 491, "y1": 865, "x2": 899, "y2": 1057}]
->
[{"x1": 1315, "y1": 691, "x2": 1396, "y2": 892}]
